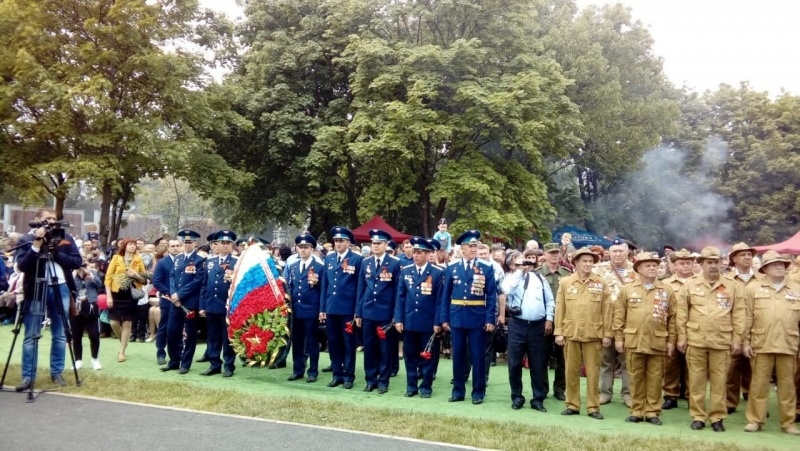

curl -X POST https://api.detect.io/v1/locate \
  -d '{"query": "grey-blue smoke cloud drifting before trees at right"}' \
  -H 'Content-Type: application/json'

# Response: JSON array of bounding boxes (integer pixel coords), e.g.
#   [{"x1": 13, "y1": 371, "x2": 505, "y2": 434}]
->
[{"x1": 592, "y1": 137, "x2": 733, "y2": 250}]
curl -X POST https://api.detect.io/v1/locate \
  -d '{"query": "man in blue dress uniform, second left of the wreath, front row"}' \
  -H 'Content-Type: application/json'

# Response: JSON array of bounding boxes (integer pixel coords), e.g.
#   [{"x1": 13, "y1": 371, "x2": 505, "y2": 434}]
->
[{"x1": 161, "y1": 230, "x2": 206, "y2": 374}]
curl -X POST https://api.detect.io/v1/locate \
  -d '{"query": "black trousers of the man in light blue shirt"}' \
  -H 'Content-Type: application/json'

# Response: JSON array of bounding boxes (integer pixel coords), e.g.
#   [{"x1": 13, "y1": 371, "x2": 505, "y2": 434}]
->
[{"x1": 508, "y1": 318, "x2": 548, "y2": 402}]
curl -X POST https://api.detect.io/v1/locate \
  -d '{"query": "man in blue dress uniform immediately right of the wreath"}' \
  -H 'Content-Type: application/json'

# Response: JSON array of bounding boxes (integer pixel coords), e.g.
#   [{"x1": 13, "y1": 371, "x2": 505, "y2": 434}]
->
[{"x1": 286, "y1": 233, "x2": 325, "y2": 383}]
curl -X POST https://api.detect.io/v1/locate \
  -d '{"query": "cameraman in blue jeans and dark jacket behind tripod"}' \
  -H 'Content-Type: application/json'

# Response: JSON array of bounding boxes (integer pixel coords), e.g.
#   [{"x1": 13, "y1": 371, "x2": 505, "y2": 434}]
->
[{"x1": 15, "y1": 207, "x2": 83, "y2": 391}]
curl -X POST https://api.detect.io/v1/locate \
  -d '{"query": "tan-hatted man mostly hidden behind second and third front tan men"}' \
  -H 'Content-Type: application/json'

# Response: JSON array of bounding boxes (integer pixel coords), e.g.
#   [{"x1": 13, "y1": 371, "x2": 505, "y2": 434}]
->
[{"x1": 661, "y1": 249, "x2": 694, "y2": 410}]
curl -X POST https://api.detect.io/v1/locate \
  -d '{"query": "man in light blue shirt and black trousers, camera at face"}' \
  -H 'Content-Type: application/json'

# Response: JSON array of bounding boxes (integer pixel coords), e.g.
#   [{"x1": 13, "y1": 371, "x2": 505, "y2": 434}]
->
[{"x1": 504, "y1": 250, "x2": 555, "y2": 412}]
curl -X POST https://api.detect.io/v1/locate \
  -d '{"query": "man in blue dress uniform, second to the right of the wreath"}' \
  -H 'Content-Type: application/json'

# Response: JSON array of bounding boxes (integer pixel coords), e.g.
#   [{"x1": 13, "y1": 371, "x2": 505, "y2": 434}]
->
[{"x1": 320, "y1": 226, "x2": 362, "y2": 389}]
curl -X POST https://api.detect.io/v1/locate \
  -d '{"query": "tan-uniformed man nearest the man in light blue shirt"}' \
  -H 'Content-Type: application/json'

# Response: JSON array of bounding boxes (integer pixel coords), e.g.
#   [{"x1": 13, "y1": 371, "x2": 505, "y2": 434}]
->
[{"x1": 554, "y1": 247, "x2": 612, "y2": 420}]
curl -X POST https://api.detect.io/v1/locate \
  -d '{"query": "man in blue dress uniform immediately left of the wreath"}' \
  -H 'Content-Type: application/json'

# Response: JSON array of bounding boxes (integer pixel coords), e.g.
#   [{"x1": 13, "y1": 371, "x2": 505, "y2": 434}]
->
[{"x1": 200, "y1": 230, "x2": 237, "y2": 377}]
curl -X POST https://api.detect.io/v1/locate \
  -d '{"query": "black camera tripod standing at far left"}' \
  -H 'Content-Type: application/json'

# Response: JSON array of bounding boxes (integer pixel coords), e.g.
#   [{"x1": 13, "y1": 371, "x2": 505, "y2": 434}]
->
[{"x1": 0, "y1": 243, "x2": 81, "y2": 403}]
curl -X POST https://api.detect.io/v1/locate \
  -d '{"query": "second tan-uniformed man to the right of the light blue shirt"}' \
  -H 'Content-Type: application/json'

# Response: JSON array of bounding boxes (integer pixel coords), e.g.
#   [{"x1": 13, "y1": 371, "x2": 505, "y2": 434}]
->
[{"x1": 613, "y1": 252, "x2": 677, "y2": 426}]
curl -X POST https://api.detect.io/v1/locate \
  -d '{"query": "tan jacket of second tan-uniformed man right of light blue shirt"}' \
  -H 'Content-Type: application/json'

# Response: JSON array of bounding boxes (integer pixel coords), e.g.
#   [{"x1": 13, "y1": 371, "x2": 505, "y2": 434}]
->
[{"x1": 613, "y1": 280, "x2": 678, "y2": 355}]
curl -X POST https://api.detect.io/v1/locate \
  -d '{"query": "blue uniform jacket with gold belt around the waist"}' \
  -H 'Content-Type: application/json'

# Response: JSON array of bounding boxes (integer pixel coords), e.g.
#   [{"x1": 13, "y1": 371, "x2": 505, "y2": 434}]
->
[{"x1": 440, "y1": 259, "x2": 497, "y2": 329}]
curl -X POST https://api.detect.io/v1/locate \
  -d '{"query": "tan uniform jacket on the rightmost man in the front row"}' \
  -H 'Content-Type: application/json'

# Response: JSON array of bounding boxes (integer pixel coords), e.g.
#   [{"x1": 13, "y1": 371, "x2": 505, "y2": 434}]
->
[{"x1": 742, "y1": 278, "x2": 800, "y2": 355}]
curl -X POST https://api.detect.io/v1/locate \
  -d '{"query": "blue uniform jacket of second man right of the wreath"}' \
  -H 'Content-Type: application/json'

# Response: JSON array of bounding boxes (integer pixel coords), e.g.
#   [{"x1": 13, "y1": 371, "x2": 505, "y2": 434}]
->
[{"x1": 320, "y1": 249, "x2": 362, "y2": 315}]
